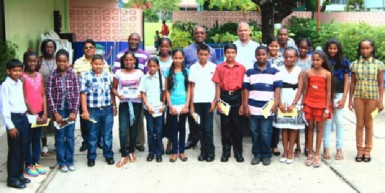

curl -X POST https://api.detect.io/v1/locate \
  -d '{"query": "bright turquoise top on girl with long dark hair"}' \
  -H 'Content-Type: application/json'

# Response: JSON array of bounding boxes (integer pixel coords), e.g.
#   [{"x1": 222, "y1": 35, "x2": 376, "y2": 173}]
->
[{"x1": 164, "y1": 69, "x2": 189, "y2": 105}]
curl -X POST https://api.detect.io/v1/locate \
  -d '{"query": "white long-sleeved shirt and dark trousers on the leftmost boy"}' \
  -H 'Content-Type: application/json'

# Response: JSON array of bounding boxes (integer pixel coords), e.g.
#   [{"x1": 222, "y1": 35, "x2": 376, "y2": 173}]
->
[{"x1": 0, "y1": 77, "x2": 29, "y2": 184}]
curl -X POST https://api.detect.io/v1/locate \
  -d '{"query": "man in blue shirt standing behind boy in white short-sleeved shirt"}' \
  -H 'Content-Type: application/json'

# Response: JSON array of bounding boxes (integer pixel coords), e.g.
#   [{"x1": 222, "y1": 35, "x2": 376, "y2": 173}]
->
[{"x1": 183, "y1": 26, "x2": 217, "y2": 149}]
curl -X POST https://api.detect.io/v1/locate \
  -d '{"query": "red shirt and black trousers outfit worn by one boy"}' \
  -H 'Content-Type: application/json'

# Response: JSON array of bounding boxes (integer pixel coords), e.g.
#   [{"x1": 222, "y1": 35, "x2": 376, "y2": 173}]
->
[{"x1": 212, "y1": 62, "x2": 246, "y2": 157}]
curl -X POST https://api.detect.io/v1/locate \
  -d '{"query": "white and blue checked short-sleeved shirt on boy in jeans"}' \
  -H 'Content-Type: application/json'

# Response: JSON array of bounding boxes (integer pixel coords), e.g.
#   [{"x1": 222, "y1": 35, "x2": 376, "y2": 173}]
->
[{"x1": 80, "y1": 70, "x2": 112, "y2": 108}]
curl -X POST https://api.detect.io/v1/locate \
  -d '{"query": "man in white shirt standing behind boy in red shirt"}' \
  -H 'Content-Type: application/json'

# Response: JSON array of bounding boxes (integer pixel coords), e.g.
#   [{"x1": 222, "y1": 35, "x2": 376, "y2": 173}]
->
[{"x1": 234, "y1": 22, "x2": 259, "y2": 69}]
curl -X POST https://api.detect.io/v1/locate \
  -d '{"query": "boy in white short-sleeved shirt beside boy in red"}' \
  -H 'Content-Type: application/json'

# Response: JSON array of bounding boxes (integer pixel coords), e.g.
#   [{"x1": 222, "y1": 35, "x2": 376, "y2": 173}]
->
[{"x1": 189, "y1": 44, "x2": 217, "y2": 162}]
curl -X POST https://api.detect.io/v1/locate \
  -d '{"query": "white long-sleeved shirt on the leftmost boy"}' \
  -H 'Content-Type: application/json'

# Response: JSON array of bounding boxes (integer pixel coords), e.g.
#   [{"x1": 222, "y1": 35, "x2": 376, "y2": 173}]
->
[{"x1": 0, "y1": 76, "x2": 27, "y2": 130}]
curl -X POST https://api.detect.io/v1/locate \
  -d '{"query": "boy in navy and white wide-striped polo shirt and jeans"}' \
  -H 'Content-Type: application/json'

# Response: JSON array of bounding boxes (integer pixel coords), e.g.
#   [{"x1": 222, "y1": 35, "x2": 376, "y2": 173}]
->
[{"x1": 243, "y1": 46, "x2": 282, "y2": 165}]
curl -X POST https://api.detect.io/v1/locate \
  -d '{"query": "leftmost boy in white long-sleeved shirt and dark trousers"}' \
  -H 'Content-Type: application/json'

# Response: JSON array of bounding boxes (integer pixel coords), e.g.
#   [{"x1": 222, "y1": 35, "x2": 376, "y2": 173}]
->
[{"x1": 0, "y1": 59, "x2": 31, "y2": 189}]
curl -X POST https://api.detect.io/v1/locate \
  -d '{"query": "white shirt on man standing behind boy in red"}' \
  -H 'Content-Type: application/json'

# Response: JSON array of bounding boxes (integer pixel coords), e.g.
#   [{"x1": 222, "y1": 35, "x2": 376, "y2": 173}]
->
[{"x1": 234, "y1": 39, "x2": 259, "y2": 70}]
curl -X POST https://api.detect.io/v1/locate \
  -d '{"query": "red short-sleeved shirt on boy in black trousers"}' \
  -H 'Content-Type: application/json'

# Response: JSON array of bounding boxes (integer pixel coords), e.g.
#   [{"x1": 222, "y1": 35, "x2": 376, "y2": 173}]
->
[{"x1": 212, "y1": 62, "x2": 246, "y2": 91}]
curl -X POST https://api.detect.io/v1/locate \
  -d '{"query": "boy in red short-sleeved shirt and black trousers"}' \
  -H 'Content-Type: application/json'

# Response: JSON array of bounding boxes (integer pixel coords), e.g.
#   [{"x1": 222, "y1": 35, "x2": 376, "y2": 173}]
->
[{"x1": 212, "y1": 44, "x2": 246, "y2": 162}]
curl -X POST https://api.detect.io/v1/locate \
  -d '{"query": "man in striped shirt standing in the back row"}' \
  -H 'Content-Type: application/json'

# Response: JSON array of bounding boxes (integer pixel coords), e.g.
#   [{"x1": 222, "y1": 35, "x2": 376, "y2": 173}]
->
[{"x1": 114, "y1": 33, "x2": 150, "y2": 151}]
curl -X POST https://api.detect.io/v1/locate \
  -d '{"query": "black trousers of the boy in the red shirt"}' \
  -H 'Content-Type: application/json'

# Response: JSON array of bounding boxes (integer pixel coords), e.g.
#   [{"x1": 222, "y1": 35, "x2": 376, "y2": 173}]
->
[{"x1": 221, "y1": 91, "x2": 243, "y2": 154}]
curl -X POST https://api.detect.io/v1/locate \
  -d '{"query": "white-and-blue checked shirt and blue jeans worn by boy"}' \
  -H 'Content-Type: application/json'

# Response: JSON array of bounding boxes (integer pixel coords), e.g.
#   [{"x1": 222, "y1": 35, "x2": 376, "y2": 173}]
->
[{"x1": 80, "y1": 70, "x2": 114, "y2": 161}]
